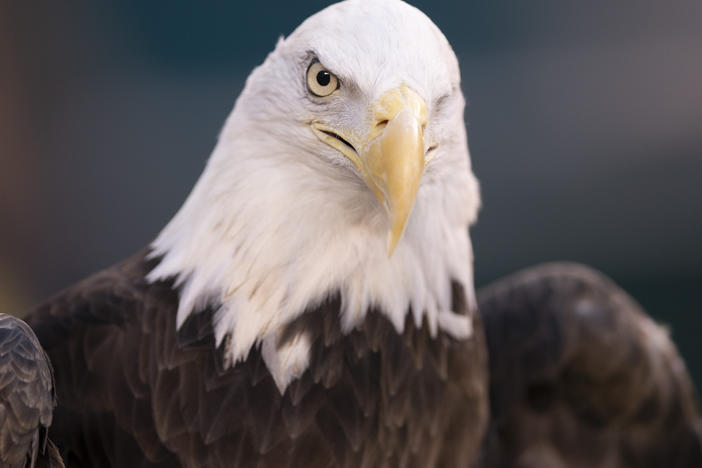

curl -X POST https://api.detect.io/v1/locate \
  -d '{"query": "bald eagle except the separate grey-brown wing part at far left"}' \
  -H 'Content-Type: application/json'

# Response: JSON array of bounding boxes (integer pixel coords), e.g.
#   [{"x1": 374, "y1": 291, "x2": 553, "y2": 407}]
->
[{"x1": 6, "y1": 0, "x2": 702, "y2": 468}]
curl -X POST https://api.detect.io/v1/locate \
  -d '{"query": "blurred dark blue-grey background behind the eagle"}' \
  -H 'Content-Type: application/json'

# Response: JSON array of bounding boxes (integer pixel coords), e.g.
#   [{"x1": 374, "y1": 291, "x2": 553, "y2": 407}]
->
[{"x1": 0, "y1": 0, "x2": 702, "y2": 386}]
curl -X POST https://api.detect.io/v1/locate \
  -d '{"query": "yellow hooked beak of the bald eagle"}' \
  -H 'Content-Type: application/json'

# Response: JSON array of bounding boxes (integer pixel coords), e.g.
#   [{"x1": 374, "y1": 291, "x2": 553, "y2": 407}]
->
[{"x1": 311, "y1": 86, "x2": 427, "y2": 257}]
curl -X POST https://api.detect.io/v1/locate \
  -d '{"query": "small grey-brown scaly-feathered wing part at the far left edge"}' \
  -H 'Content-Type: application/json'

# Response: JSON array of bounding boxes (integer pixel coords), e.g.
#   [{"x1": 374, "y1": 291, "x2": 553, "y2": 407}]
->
[{"x1": 0, "y1": 314, "x2": 63, "y2": 468}]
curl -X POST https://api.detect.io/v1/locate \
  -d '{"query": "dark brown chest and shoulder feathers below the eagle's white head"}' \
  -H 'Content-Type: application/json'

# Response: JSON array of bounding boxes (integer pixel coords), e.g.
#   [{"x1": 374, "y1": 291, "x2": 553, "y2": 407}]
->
[{"x1": 27, "y1": 255, "x2": 487, "y2": 468}]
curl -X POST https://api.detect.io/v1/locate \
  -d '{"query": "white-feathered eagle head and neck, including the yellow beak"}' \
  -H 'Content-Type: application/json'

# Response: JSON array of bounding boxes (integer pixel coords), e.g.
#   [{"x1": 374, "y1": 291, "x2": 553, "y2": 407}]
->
[{"x1": 149, "y1": 0, "x2": 480, "y2": 391}]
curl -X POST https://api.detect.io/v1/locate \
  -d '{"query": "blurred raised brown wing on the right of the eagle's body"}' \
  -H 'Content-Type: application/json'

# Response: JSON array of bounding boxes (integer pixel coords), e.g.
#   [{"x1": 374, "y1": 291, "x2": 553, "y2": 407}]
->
[{"x1": 478, "y1": 264, "x2": 702, "y2": 468}]
